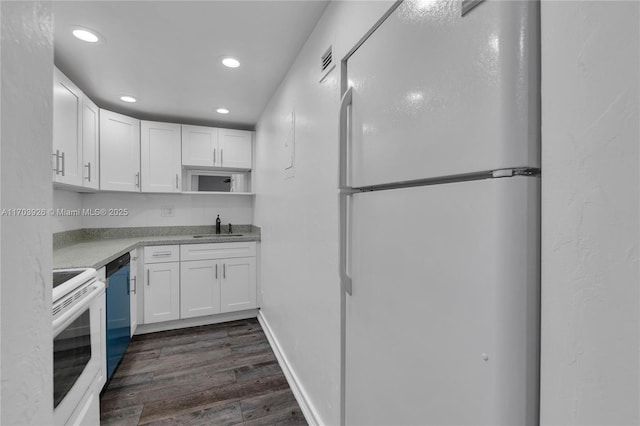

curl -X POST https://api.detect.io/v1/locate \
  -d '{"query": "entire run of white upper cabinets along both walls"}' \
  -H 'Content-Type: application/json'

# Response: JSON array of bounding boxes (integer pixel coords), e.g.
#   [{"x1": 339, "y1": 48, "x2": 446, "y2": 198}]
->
[{"x1": 52, "y1": 72, "x2": 253, "y2": 193}]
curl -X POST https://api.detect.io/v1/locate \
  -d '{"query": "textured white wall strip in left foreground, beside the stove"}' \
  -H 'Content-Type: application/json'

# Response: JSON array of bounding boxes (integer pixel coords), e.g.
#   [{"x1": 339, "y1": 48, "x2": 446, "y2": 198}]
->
[{"x1": 0, "y1": 1, "x2": 53, "y2": 425}]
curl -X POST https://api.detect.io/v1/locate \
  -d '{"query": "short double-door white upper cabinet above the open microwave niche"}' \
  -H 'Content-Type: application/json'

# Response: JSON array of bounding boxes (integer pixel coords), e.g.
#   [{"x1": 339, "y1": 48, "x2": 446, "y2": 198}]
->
[{"x1": 182, "y1": 125, "x2": 252, "y2": 170}]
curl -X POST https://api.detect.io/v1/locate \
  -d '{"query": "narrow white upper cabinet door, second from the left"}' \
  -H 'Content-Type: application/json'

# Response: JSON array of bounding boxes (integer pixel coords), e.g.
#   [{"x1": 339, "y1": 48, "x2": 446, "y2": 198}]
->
[{"x1": 82, "y1": 96, "x2": 100, "y2": 189}]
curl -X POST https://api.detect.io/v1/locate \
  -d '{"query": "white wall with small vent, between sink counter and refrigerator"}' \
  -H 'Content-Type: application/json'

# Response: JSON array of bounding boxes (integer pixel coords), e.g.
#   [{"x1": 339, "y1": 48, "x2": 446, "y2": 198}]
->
[{"x1": 254, "y1": 1, "x2": 393, "y2": 425}]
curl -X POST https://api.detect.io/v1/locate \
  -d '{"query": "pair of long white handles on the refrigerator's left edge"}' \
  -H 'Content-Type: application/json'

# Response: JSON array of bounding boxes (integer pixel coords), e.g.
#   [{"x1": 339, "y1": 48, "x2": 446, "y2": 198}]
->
[{"x1": 338, "y1": 87, "x2": 353, "y2": 295}]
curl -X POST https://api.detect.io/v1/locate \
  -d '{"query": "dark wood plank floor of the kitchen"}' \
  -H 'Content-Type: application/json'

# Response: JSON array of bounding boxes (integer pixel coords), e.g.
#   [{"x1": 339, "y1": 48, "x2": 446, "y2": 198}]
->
[{"x1": 100, "y1": 319, "x2": 307, "y2": 426}]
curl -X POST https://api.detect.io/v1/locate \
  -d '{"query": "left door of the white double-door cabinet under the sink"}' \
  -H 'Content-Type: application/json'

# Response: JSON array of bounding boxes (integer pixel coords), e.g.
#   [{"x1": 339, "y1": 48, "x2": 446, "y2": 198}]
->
[{"x1": 180, "y1": 260, "x2": 222, "y2": 318}]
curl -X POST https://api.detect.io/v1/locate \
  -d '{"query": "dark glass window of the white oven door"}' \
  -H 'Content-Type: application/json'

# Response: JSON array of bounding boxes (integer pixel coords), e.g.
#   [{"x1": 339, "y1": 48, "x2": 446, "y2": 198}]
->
[{"x1": 53, "y1": 309, "x2": 91, "y2": 408}]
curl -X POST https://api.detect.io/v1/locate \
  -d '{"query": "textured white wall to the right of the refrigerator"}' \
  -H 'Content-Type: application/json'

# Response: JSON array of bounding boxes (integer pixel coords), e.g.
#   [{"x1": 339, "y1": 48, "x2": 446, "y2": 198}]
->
[{"x1": 541, "y1": 1, "x2": 640, "y2": 425}]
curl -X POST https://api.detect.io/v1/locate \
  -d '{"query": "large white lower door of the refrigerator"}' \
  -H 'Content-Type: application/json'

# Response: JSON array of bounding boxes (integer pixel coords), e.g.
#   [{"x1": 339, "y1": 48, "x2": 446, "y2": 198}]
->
[{"x1": 344, "y1": 177, "x2": 540, "y2": 425}]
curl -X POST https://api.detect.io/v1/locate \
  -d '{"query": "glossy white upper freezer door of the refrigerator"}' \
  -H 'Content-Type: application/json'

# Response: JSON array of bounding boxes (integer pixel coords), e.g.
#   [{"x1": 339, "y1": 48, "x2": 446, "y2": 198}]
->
[{"x1": 346, "y1": 0, "x2": 540, "y2": 187}]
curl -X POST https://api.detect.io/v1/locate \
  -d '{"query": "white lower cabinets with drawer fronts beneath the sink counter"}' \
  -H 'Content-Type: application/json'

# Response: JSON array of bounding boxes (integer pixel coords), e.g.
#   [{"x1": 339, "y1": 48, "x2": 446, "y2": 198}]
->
[{"x1": 140, "y1": 241, "x2": 258, "y2": 324}]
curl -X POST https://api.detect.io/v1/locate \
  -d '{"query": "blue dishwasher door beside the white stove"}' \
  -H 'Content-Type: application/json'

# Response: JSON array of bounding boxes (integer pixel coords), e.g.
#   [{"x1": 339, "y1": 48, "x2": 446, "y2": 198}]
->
[{"x1": 106, "y1": 263, "x2": 131, "y2": 380}]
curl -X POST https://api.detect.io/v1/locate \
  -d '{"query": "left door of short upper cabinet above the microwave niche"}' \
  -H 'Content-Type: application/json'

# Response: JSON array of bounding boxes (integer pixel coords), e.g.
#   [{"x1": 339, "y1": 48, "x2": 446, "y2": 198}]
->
[{"x1": 182, "y1": 125, "x2": 220, "y2": 167}]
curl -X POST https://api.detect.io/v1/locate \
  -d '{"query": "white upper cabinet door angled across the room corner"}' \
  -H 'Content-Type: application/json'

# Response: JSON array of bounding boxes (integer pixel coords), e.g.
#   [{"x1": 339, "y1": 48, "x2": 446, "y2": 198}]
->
[{"x1": 100, "y1": 109, "x2": 140, "y2": 192}]
